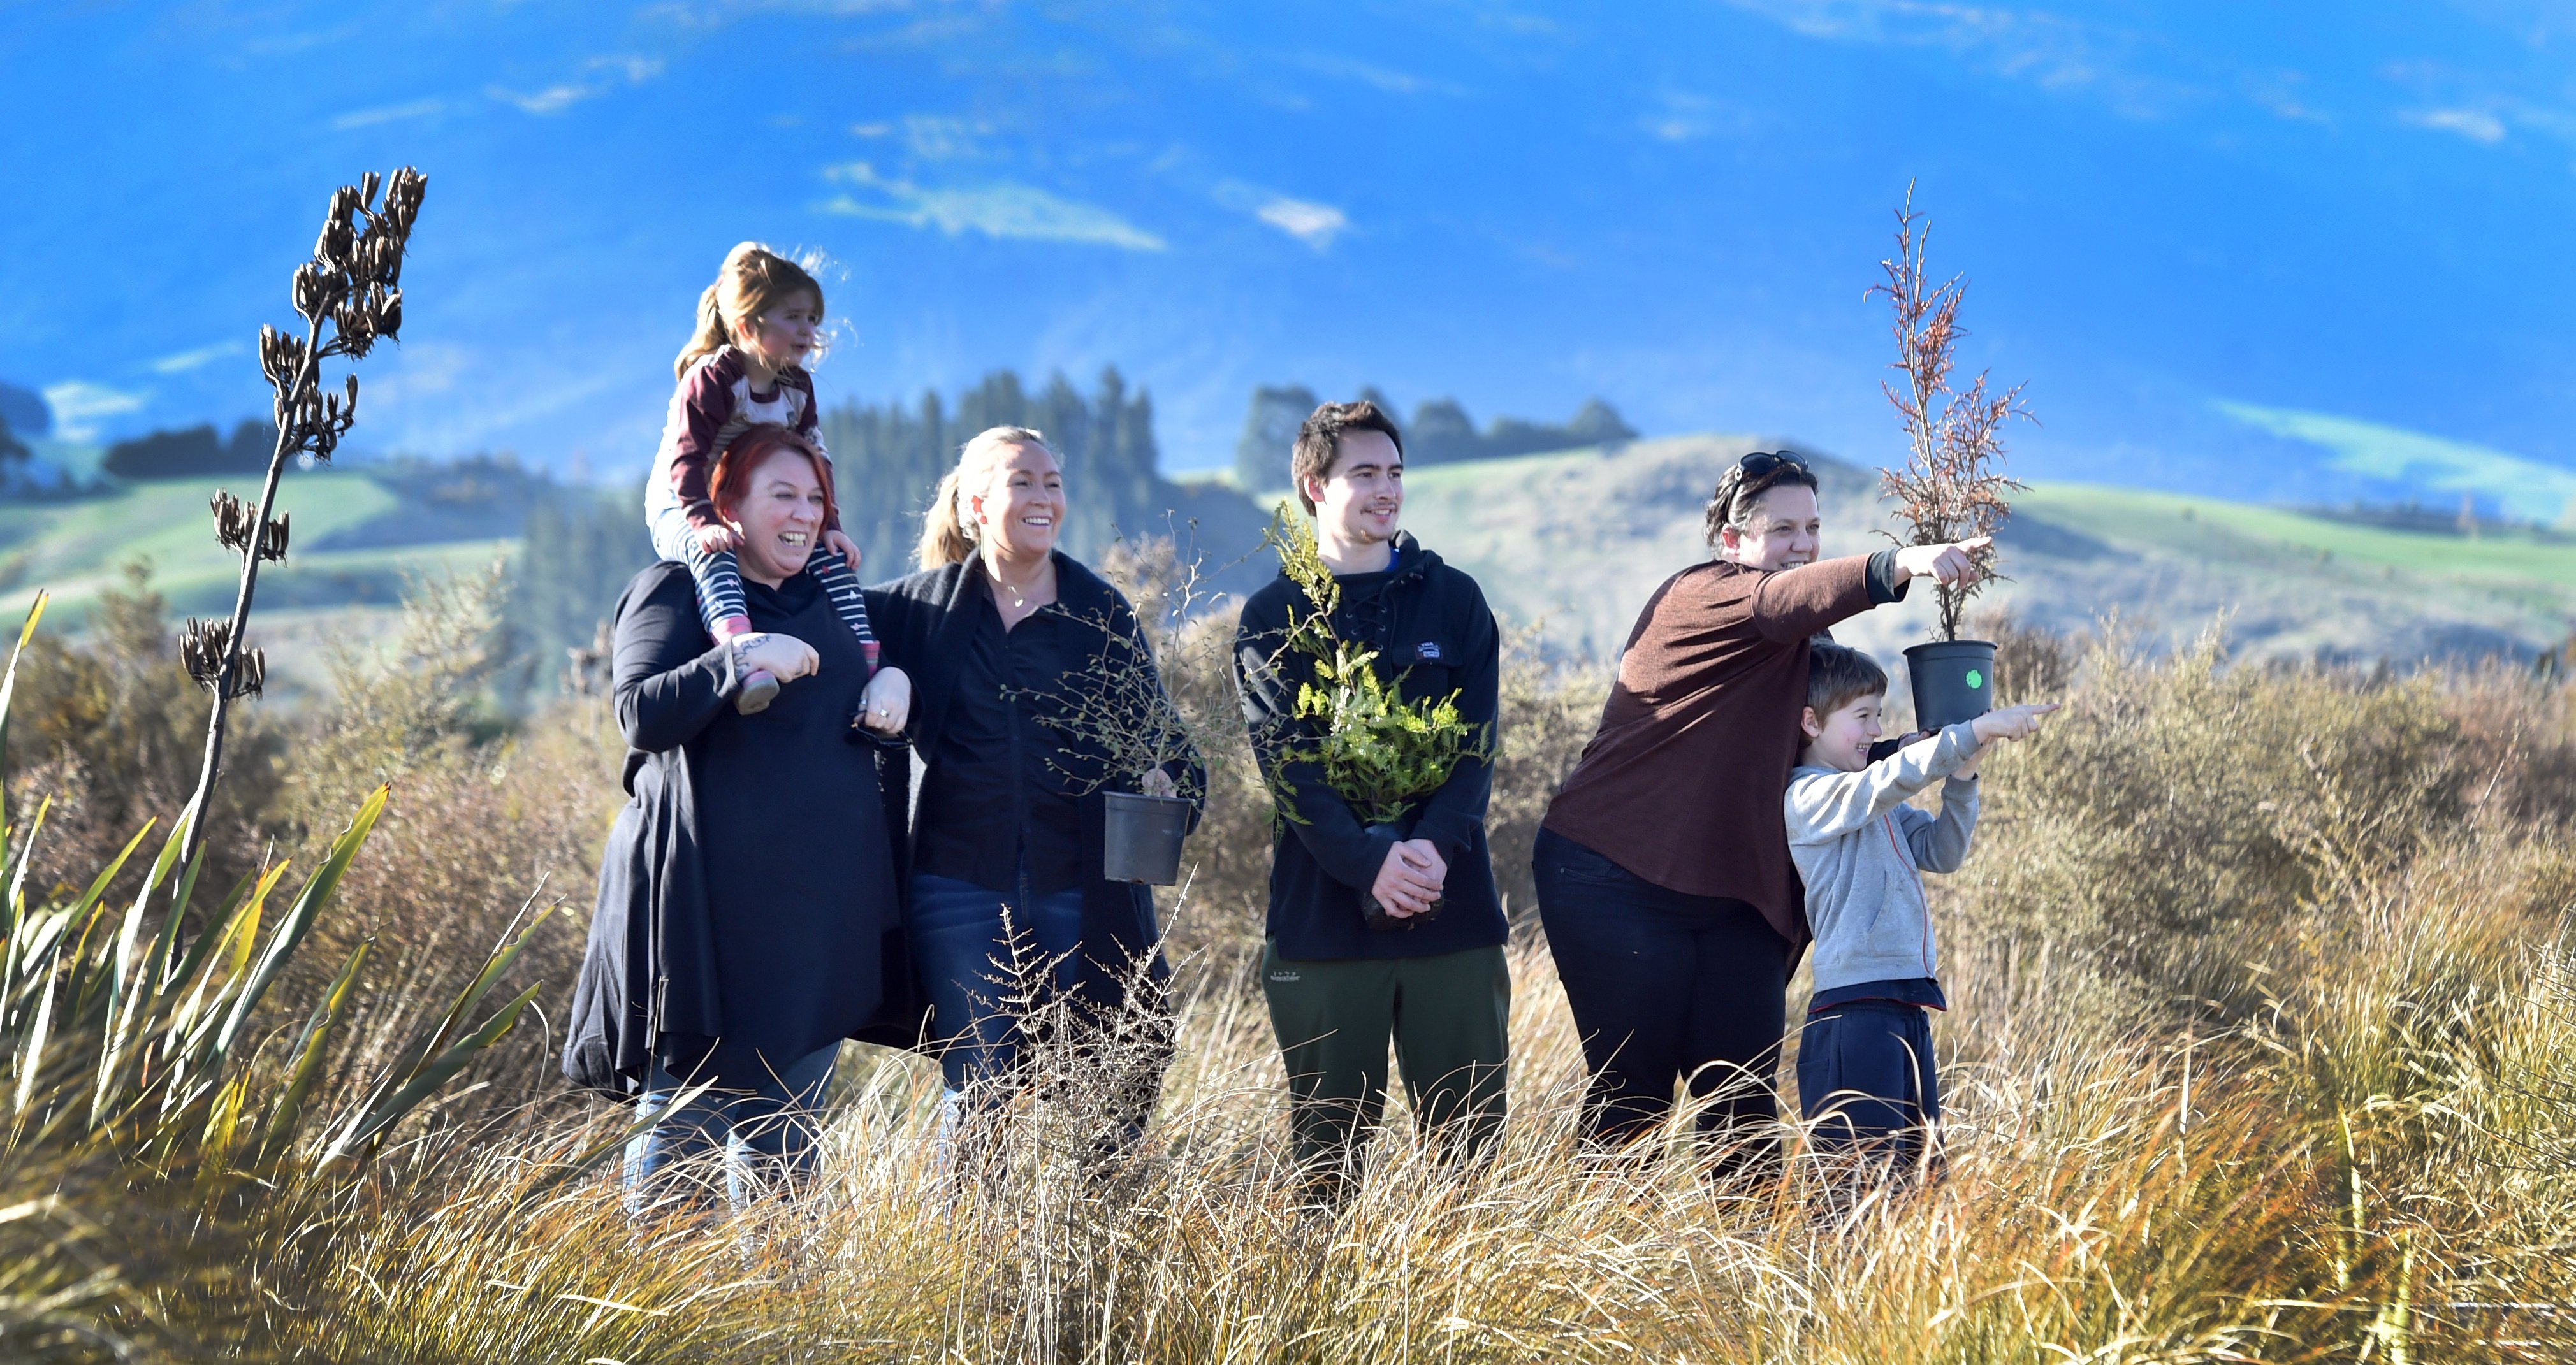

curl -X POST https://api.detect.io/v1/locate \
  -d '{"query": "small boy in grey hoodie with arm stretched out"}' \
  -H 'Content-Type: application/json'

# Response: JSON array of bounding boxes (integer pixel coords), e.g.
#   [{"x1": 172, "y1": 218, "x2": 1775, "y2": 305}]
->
[{"x1": 1785, "y1": 641, "x2": 2056, "y2": 1167}]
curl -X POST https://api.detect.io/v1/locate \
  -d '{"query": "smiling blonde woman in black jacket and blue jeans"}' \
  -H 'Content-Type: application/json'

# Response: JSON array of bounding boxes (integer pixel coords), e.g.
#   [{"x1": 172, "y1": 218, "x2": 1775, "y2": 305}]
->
[{"x1": 868, "y1": 428, "x2": 1205, "y2": 1159}]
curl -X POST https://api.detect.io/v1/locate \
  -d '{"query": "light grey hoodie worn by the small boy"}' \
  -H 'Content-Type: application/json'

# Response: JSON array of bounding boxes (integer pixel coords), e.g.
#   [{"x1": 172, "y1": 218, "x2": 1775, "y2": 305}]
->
[{"x1": 1782, "y1": 721, "x2": 1976, "y2": 992}]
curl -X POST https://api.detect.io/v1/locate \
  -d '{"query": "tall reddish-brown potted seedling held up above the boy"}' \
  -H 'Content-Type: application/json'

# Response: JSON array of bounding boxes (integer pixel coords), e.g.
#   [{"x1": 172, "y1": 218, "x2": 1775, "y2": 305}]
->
[{"x1": 1870, "y1": 191, "x2": 2030, "y2": 729}]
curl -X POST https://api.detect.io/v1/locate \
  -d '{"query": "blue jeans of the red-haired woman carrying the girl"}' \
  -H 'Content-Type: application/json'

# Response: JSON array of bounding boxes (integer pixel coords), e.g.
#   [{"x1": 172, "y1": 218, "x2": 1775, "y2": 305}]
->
[{"x1": 626, "y1": 1043, "x2": 840, "y2": 1211}]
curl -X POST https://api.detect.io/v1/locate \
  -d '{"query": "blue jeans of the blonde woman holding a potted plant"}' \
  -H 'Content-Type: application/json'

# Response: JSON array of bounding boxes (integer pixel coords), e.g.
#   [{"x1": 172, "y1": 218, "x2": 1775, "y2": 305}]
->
[{"x1": 904, "y1": 870, "x2": 1082, "y2": 1087}]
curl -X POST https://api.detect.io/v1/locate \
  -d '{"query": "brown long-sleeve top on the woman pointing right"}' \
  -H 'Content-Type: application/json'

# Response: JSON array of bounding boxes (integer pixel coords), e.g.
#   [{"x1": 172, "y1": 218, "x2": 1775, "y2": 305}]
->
[{"x1": 1546, "y1": 551, "x2": 1903, "y2": 945}]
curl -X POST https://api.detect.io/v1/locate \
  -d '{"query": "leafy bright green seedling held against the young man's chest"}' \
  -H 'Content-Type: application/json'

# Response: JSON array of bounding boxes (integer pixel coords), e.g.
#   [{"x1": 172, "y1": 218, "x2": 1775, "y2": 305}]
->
[{"x1": 1265, "y1": 502, "x2": 1494, "y2": 932}]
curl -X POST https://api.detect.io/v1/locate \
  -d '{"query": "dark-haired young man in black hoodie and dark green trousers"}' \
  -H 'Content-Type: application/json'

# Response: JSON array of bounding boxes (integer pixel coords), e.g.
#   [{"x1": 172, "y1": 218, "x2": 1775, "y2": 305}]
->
[{"x1": 1234, "y1": 401, "x2": 1512, "y2": 1197}]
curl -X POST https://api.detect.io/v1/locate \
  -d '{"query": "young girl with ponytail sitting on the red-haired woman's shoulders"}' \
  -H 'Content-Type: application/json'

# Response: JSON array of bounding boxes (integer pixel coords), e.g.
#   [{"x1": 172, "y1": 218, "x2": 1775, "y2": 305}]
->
[{"x1": 644, "y1": 242, "x2": 876, "y2": 713}]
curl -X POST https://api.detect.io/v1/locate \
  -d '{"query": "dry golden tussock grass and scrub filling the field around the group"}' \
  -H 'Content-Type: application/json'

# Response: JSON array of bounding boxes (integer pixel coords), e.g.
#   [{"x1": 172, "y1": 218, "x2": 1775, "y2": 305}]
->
[{"x1": 0, "y1": 572, "x2": 2576, "y2": 1365}]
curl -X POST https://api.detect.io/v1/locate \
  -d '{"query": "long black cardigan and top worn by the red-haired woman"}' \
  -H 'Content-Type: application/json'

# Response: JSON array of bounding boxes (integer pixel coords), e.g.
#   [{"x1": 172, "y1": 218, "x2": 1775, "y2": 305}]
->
[{"x1": 564, "y1": 564, "x2": 922, "y2": 1097}]
